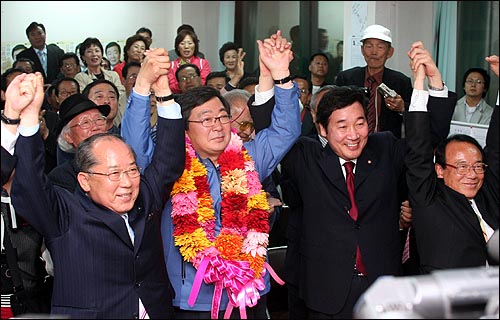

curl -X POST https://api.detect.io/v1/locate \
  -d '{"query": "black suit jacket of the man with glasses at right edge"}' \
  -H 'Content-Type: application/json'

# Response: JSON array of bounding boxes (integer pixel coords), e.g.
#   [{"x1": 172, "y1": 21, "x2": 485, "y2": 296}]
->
[{"x1": 406, "y1": 107, "x2": 499, "y2": 273}]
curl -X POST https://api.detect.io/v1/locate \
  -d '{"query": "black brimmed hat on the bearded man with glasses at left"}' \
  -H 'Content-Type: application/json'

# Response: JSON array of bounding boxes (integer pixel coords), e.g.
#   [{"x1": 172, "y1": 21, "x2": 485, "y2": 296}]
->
[{"x1": 56, "y1": 93, "x2": 111, "y2": 136}]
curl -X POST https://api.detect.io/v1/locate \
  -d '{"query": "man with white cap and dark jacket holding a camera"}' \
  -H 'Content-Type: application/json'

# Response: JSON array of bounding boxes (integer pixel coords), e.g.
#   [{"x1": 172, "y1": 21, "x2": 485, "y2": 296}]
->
[{"x1": 335, "y1": 24, "x2": 413, "y2": 138}]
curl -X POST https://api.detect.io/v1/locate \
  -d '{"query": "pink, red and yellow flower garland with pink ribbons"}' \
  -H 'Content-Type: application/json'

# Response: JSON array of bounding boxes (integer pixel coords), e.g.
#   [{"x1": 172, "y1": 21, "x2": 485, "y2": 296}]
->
[{"x1": 171, "y1": 132, "x2": 269, "y2": 319}]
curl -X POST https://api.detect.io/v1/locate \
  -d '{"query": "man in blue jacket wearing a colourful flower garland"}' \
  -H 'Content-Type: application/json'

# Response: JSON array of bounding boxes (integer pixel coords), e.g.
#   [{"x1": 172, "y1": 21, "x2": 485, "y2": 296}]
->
[{"x1": 122, "y1": 31, "x2": 300, "y2": 319}]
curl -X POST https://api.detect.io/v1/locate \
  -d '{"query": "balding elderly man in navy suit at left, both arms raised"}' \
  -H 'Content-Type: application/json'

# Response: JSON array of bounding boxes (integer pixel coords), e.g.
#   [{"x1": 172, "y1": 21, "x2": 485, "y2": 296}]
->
[{"x1": 7, "y1": 49, "x2": 185, "y2": 318}]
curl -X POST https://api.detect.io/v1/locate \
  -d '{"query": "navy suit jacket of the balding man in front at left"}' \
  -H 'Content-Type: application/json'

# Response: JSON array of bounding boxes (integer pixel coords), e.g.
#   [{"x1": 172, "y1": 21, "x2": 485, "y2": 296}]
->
[{"x1": 12, "y1": 118, "x2": 185, "y2": 319}]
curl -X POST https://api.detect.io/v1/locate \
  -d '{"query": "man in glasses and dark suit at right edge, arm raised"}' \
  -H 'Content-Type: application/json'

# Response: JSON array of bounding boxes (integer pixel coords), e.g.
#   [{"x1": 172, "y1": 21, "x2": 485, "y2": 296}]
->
[{"x1": 406, "y1": 42, "x2": 499, "y2": 273}]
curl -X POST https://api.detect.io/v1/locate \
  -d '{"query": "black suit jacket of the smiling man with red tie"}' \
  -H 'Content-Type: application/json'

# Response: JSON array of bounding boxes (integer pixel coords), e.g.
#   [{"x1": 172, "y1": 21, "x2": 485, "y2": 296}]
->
[{"x1": 281, "y1": 95, "x2": 456, "y2": 314}]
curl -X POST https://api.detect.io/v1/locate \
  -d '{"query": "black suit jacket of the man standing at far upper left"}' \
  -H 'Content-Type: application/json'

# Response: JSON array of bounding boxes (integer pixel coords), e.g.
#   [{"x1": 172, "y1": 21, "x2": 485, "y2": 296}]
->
[{"x1": 17, "y1": 43, "x2": 64, "y2": 84}]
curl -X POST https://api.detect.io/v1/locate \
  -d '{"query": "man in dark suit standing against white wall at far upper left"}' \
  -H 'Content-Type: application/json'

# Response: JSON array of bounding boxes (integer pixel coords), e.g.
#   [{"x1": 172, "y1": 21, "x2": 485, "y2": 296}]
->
[{"x1": 17, "y1": 22, "x2": 64, "y2": 85}]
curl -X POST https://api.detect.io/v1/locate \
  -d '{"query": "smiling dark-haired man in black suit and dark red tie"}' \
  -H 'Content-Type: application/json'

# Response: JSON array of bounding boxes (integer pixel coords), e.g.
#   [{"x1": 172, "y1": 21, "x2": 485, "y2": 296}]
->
[{"x1": 281, "y1": 63, "x2": 456, "y2": 318}]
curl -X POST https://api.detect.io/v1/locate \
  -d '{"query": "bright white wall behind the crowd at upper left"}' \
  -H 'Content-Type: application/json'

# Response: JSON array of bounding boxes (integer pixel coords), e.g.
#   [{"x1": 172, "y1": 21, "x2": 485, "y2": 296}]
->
[{"x1": 1, "y1": 1, "x2": 229, "y2": 72}]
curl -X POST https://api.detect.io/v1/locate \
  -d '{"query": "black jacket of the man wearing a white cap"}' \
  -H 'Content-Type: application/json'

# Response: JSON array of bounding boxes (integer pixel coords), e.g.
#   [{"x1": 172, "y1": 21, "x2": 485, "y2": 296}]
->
[{"x1": 335, "y1": 67, "x2": 413, "y2": 138}]
